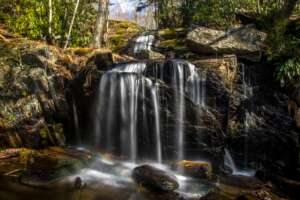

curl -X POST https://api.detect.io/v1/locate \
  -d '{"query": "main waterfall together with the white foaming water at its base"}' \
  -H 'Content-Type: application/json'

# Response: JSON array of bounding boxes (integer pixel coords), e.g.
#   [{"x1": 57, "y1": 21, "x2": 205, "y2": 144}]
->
[{"x1": 74, "y1": 60, "x2": 210, "y2": 197}]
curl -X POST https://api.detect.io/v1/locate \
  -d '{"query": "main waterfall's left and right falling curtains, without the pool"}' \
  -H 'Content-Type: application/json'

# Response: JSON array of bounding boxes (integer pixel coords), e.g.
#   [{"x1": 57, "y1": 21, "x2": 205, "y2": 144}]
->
[{"x1": 94, "y1": 60, "x2": 206, "y2": 163}]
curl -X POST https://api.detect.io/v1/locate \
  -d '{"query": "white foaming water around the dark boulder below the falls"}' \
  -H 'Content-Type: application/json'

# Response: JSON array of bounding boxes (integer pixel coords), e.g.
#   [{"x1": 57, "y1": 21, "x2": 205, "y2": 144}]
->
[{"x1": 66, "y1": 159, "x2": 210, "y2": 199}]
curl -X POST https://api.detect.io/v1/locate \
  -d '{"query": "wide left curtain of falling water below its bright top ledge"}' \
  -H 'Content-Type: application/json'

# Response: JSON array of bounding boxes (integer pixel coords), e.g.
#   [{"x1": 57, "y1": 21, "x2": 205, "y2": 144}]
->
[{"x1": 95, "y1": 72, "x2": 141, "y2": 161}]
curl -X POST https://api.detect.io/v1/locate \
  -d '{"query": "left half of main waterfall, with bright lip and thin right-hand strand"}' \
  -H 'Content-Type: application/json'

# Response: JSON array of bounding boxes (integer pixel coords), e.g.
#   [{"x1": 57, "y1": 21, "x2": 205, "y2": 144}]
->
[{"x1": 95, "y1": 62, "x2": 162, "y2": 162}]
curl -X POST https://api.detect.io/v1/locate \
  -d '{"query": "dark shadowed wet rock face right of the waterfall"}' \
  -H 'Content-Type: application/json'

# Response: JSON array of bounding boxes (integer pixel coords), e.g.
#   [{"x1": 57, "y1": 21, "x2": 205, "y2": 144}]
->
[{"x1": 228, "y1": 64, "x2": 299, "y2": 177}]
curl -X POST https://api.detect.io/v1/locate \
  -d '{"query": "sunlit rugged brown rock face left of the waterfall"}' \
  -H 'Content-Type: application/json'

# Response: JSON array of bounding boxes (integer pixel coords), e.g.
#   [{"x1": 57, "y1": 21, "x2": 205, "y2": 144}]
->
[{"x1": 0, "y1": 41, "x2": 71, "y2": 148}]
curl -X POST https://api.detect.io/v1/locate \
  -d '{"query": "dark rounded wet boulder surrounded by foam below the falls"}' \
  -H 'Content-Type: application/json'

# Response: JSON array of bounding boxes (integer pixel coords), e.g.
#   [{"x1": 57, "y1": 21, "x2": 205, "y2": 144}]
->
[{"x1": 132, "y1": 165, "x2": 179, "y2": 192}]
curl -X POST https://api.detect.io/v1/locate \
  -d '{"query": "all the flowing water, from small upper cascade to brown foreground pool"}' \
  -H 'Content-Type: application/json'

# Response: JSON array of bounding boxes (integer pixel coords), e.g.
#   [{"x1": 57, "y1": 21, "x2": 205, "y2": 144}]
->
[{"x1": 0, "y1": 35, "x2": 253, "y2": 200}]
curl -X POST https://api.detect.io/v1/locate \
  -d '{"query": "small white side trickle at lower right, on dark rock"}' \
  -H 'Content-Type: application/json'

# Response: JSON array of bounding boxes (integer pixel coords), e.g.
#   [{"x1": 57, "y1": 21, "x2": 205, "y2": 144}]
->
[{"x1": 224, "y1": 149, "x2": 255, "y2": 177}]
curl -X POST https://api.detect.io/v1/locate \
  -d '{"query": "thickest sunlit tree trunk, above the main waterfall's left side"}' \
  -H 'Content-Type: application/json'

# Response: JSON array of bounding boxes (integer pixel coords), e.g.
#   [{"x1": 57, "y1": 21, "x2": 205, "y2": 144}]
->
[{"x1": 92, "y1": 0, "x2": 109, "y2": 48}]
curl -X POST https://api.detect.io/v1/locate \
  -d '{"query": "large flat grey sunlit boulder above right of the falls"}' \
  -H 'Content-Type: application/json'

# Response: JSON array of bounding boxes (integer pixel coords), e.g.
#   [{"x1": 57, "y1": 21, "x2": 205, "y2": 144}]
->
[{"x1": 187, "y1": 25, "x2": 267, "y2": 61}]
